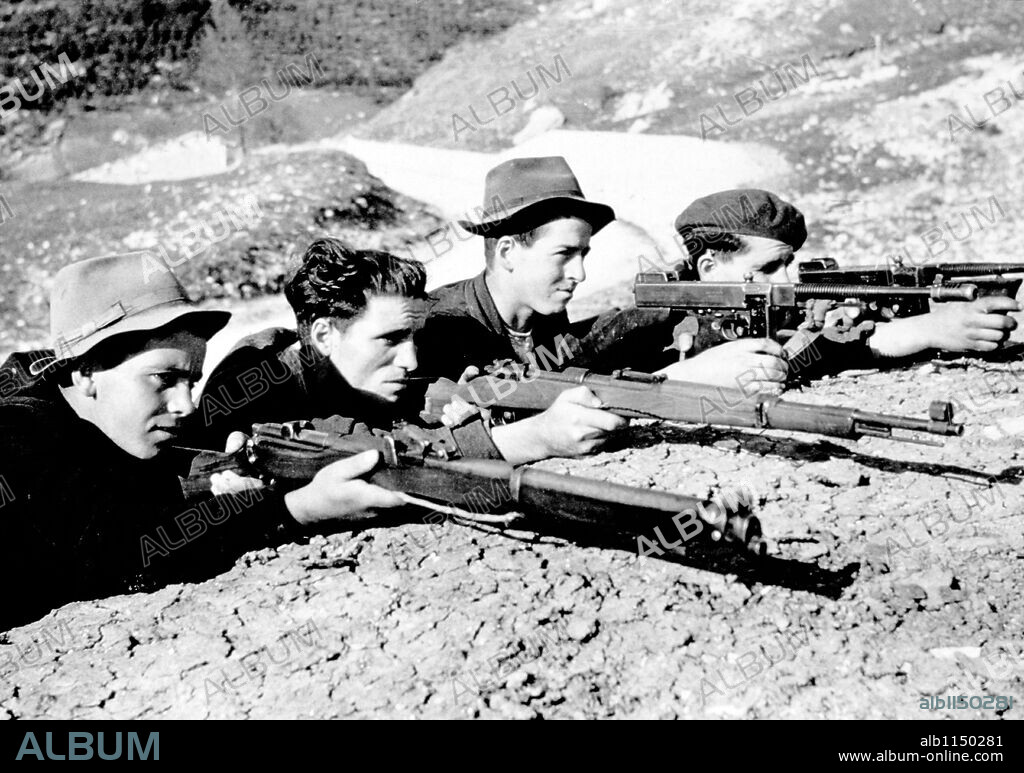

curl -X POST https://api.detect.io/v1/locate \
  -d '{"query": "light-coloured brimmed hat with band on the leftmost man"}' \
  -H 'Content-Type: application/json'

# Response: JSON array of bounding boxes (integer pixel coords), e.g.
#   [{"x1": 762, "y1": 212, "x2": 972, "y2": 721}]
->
[{"x1": 31, "y1": 250, "x2": 231, "y2": 375}]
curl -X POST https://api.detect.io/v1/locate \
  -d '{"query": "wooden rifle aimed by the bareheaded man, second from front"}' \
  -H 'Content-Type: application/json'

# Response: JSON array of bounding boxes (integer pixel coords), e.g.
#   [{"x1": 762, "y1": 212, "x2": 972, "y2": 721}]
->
[{"x1": 426, "y1": 360, "x2": 964, "y2": 445}]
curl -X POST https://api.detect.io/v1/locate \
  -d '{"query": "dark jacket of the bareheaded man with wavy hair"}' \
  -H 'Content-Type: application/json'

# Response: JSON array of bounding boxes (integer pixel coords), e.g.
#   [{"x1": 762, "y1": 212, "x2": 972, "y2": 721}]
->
[{"x1": 193, "y1": 328, "x2": 501, "y2": 459}]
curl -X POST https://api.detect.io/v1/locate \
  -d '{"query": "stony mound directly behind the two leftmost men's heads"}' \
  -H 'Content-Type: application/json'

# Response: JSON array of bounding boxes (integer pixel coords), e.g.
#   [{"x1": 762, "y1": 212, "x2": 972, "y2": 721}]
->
[{"x1": 0, "y1": 152, "x2": 440, "y2": 351}]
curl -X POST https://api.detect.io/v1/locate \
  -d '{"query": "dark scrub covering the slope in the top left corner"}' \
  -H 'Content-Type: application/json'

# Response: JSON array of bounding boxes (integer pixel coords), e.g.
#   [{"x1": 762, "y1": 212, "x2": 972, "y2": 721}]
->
[{"x1": 0, "y1": 0, "x2": 534, "y2": 122}]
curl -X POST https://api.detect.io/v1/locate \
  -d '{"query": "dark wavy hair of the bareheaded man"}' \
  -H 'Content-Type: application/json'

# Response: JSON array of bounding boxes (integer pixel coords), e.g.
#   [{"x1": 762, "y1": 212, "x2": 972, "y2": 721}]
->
[{"x1": 285, "y1": 238, "x2": 427, "y2": 340}]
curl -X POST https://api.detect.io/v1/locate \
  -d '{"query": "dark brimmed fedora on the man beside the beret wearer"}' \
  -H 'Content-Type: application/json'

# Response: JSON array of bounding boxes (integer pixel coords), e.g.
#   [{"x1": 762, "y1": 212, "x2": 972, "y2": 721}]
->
[{"x1": 458, "y1": 156, "x2": 615, "y2": 237}]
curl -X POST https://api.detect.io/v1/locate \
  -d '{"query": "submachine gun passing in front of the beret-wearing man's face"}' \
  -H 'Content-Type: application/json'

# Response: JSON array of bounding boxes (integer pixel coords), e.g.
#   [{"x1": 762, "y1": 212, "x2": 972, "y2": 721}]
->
[{"x1": 633, "y1": 271, "x2": 978, "y2": 358}]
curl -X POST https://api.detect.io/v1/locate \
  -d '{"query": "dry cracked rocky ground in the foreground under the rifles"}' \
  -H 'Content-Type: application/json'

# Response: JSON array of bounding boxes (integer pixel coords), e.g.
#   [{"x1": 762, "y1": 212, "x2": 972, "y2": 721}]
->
[{"x1": 0, "y1": 344, "x2": 1024, "y2": 719}]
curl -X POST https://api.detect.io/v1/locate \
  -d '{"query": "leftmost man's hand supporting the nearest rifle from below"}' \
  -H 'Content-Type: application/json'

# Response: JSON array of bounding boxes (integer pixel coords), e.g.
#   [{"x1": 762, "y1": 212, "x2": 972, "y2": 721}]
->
[{"x1": 285, "y1": 450, "x2": 403, "y2": 526}]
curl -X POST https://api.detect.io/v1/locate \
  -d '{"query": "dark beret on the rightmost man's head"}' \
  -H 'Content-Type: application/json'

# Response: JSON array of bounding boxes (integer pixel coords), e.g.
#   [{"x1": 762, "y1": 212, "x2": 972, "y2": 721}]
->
[{"x1": 676, "y1": 188, "x2": 807, "y2": 250}]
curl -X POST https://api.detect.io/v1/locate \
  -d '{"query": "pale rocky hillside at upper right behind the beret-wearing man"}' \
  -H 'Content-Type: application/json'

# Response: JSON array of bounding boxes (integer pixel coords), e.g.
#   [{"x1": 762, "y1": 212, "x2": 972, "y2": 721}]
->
[{"x1": 361, "y1": 0, "x2": 1024, "y2": 263}]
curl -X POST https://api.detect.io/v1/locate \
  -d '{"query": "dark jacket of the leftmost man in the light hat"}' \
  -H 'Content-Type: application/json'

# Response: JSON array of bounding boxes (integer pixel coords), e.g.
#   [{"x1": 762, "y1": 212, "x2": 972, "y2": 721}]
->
[{"x1": 0, "y1": 354, "x2": 301, "y2": 630}]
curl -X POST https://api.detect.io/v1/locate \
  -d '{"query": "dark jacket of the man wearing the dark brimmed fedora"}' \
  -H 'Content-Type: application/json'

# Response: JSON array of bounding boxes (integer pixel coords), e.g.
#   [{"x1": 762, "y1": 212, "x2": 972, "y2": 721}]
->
[{"x1": 416, "y1": 273, "x2": 679, "y2": 379}]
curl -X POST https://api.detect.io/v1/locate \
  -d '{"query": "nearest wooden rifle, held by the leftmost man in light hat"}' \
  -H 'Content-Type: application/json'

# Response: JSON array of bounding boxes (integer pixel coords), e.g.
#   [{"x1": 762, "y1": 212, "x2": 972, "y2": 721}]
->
[{"x1": 182, "y1": 417, "x2": 767, "y2": 556}]
